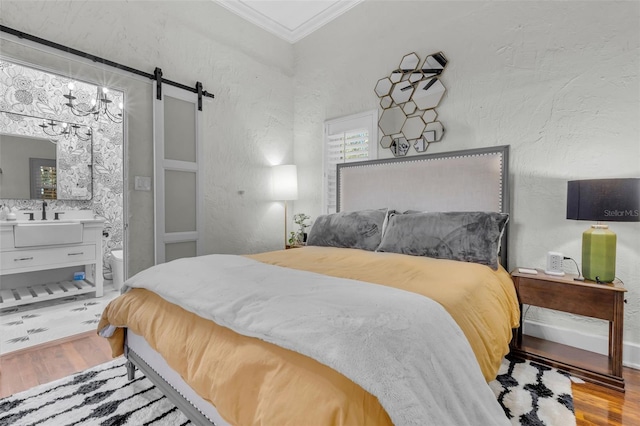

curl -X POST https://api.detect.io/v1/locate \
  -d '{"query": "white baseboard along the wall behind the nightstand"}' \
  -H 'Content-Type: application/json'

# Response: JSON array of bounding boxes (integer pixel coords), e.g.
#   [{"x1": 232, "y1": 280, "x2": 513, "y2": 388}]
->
[{"x1": 524, "y1": 321, "x2": 640, "y2": 370}]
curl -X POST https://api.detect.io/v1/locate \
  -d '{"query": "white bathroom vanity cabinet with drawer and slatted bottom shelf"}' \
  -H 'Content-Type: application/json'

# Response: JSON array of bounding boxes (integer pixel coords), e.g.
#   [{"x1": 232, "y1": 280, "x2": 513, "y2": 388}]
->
[{"x1": 0, "y1": 218, "x2": 104, "y2": 309}]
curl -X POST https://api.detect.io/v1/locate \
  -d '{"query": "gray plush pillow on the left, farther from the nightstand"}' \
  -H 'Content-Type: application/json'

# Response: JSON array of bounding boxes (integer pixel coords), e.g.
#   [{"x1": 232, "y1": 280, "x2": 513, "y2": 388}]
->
[{"x1": 307, "y1": 209, "x2": 387, "y2": 251}]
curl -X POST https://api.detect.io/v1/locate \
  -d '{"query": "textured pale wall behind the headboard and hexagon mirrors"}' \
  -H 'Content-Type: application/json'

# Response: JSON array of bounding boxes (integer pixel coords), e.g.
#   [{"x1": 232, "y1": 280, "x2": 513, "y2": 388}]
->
[{"x1": 294, "y1": 0, "x2": 640, "y2": 366}]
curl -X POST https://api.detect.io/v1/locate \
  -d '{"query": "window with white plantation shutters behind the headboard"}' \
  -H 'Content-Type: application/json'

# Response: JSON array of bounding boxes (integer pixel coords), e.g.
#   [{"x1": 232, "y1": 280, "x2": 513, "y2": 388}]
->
[{"x1": 323, "y1": 110, "x2": 378, "y2": 213}]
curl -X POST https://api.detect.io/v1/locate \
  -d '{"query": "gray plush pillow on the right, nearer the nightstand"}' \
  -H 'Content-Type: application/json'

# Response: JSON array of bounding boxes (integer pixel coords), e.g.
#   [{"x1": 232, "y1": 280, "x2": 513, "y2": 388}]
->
[{"x1": 377, "y1": 212, "x2": 509, "y2": 269}]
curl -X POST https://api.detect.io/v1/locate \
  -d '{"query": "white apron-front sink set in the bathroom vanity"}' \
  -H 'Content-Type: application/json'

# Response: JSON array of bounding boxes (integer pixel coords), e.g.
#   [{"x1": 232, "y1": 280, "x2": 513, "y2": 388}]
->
[{"x1": 13, "y1": 222, "x2": 83, "y2": 247}]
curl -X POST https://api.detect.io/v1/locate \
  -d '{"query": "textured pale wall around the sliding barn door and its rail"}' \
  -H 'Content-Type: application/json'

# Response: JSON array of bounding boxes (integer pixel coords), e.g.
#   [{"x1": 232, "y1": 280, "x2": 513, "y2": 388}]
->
[{"x1": 0, "y1": 0, "x2": 293, "y2": 275}]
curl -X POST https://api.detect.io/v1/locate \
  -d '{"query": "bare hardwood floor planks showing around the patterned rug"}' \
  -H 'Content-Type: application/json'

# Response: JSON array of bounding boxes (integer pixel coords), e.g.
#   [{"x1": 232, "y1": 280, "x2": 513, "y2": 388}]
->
[{"x1": 0, "y1": 332, "x2": 640, "y2": 426}]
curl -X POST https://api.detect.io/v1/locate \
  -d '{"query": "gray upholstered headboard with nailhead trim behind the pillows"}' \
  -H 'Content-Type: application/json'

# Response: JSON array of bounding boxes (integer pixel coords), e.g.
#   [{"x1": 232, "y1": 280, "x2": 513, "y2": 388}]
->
[{"x1": 337, "y1": 145, "x2": 510, "y2": 268}]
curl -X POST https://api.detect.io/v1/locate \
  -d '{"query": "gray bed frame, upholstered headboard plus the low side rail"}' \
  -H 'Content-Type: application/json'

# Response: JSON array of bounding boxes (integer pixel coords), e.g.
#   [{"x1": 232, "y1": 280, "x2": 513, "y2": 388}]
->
[{"x1": 125, "y1": 145, "x2": 510, "y2": 426}]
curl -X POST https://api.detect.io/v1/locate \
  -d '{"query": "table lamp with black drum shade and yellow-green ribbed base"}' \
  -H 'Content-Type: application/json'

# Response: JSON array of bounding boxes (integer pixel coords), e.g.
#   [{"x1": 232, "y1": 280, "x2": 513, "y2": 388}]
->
[{"x1": 567, "y1": 178, "x2": 640, "y2": 283}]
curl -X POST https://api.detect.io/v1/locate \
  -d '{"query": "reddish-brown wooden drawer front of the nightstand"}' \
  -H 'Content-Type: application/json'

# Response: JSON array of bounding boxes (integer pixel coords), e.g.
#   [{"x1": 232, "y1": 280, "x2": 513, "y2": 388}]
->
[{"x1": 518, "y1": 277, "x2": 616, "y2": 321}]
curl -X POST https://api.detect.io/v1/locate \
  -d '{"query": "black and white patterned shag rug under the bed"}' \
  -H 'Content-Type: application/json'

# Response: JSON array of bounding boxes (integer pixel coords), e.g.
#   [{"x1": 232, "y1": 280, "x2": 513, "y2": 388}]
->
[{"x1": 0, "y1": 358, "x2": 575, "y2": 426}]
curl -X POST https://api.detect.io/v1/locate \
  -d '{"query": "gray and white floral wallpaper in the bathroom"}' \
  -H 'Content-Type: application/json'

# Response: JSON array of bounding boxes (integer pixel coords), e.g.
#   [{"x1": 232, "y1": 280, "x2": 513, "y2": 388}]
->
[{"x1": 0, "y1": 60, "x2": 124, "y2": 272}]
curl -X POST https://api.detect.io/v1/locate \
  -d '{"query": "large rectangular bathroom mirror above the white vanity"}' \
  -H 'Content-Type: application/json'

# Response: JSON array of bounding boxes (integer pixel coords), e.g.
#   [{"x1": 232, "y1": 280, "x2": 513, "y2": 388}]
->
[{"x1": 0, "y1": 115, "x2": 93, "y2": 200}]
